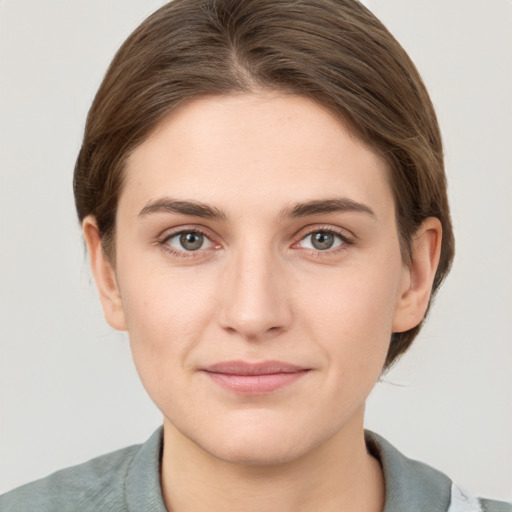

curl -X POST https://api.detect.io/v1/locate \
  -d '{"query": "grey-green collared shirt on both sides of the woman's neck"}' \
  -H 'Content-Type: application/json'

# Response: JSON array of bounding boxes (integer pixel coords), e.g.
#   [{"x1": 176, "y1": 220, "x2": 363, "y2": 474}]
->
[{"x1": 0, "y1": 428, "x2": 512, "y2": 512}]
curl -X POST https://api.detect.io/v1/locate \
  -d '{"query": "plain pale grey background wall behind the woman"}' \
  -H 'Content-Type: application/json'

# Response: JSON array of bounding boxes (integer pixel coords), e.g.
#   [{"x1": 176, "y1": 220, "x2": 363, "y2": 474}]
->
[{"x1": 0, "y1": 0, "x2": 512, "y2": 500}]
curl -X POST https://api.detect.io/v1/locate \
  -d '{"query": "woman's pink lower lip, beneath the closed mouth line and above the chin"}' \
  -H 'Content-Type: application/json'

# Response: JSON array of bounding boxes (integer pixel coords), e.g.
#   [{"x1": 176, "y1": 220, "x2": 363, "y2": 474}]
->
[{"x1": 205, "y1": 370, "x2": 308, "y2": 395}]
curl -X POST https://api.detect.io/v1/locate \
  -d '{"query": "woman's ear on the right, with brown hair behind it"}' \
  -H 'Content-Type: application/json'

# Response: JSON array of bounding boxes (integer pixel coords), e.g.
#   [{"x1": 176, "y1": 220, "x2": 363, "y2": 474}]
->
[{"x1": 393, "y1": 217, "x2": 443, "y2": 332}]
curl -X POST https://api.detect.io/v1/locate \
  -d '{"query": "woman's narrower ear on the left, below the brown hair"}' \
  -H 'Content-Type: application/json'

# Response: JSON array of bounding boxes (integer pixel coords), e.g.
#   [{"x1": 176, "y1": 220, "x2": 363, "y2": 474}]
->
[{"x1": 82, "y1": 215, "x2": 126, "y2": 331}]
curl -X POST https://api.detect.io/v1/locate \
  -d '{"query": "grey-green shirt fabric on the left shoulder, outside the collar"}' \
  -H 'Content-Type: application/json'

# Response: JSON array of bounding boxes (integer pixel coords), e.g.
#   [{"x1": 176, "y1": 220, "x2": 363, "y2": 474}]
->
[{"x1": 0, "y1": 445, "x2": 141, "y2": 512}]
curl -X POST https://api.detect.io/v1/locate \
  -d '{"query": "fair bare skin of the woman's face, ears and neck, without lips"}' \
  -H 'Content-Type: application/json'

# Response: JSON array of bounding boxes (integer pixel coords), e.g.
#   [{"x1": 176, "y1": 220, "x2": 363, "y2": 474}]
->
[{"x1": 83, "y1": 92, "x2": 441, "y2": 512}]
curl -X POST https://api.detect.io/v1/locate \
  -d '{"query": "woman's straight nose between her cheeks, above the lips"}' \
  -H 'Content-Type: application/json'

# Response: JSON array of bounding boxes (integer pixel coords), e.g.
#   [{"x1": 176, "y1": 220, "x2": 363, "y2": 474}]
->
[{"x1": 219, "y1": 246, "x2": 293, "y2": 341}]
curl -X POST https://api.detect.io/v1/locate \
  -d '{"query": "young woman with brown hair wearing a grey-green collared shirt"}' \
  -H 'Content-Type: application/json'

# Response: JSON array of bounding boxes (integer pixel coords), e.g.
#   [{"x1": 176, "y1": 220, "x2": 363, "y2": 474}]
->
[{"x1": 0, "y1": 0, "x2": 510, "y2": 512}]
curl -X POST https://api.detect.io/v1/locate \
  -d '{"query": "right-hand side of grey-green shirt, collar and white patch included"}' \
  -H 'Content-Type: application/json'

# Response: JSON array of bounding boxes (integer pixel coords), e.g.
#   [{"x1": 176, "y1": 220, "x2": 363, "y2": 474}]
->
[{"x1": 366, "y1": 431, "x2": 512, "y2": 512}]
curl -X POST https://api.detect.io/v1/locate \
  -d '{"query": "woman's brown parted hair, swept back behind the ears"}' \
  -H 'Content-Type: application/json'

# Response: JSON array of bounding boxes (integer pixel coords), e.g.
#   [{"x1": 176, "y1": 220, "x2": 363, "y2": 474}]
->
[{"x1": 73, "y1": 0, "x2": 454, "y2": 368}]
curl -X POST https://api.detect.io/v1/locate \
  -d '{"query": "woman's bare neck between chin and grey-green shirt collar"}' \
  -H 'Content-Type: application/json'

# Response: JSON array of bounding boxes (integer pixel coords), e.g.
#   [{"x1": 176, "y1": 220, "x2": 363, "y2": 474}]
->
[{"x1": 161, "y1": 411, "x2": 384, "y2": 512}]
